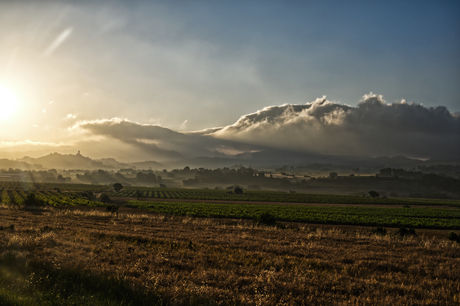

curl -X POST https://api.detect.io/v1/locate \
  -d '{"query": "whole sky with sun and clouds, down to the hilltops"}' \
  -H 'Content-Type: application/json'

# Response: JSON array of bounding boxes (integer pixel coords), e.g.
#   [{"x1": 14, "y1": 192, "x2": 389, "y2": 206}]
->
[{"x1": 0, "y1": 1, "x2": 460, "y2": 161}]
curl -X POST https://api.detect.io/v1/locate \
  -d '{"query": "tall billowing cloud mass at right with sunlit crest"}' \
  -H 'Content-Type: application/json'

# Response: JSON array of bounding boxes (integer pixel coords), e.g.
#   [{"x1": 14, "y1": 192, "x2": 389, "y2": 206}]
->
[{"x1": 214, "y1": 94, "x2": 460, "y2": 158}]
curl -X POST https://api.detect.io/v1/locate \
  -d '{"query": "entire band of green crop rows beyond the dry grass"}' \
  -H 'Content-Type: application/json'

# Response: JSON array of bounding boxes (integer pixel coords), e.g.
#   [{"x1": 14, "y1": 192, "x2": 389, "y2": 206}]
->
[{"x1": 1, "y1": 182, "x2": 460, "y2": 229}]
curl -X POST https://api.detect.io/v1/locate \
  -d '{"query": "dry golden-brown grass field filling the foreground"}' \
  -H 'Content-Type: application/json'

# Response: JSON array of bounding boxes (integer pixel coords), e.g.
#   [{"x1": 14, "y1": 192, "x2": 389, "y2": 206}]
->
[{"x1": 0, "y1": 208, "x2": 460, "y2": 305}]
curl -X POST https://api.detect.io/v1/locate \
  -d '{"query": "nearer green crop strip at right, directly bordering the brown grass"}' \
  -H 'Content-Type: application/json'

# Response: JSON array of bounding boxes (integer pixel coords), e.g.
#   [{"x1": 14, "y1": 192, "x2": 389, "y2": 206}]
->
[{"x1": 125, "y1": 201, "x2": 460, "y2": 229}]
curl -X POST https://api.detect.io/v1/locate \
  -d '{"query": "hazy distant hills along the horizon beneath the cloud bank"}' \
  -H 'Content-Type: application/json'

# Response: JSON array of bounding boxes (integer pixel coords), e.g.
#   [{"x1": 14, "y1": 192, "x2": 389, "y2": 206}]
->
[{"x1": 0, "y1": 150, "x2": 452, "y2": 170}]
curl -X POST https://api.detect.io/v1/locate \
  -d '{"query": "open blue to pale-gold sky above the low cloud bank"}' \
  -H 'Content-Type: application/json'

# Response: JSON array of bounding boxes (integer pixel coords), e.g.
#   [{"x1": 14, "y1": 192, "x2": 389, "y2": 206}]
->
[{"x1": 0, "y1": 1, "x2": 460, "y2": 160}]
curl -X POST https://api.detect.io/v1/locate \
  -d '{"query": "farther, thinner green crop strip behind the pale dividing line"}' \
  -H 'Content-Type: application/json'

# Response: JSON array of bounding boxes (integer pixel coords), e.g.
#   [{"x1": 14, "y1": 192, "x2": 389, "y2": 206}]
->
[{"x1": 113, "y1": 188, "x2": 460, "y2": 207}]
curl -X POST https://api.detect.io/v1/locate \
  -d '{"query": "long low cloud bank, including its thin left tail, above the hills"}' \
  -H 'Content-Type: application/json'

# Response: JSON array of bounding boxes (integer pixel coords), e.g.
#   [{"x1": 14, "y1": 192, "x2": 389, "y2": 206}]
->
[{"x1": 73, "y1": 93, "x2": 460, "y2": 160}]
